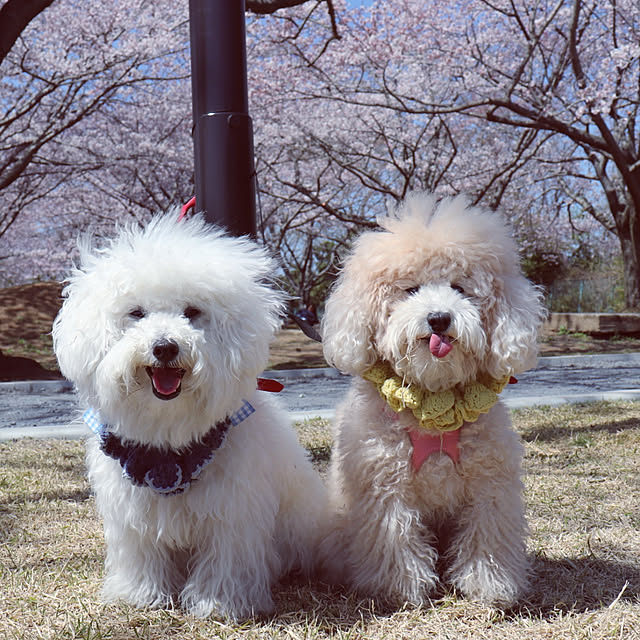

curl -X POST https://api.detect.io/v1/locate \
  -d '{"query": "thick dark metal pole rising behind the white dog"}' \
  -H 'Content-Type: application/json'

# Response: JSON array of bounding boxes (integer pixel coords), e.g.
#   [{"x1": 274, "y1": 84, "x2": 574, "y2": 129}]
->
[{"x1": 189, "y1": 0, "x2": 256, "y2": 235}]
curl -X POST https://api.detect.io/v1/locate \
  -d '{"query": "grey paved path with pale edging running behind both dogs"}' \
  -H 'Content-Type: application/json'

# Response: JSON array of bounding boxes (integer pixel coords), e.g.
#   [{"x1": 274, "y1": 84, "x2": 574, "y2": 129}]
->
[{"x1": 0, "y1": 353, "x2": 640, "y2": 440}]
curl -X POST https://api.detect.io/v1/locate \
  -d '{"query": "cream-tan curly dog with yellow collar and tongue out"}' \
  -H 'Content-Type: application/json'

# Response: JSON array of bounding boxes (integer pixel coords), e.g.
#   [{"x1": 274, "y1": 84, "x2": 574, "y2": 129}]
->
[{"x1": 322, "y1": 194, "x2": 544, "y2": 605}]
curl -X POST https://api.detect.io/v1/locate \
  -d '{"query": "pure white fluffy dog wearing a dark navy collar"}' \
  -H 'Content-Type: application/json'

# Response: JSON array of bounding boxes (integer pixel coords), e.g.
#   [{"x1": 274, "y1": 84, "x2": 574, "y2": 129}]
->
[{"x1": 53, "y1": 214, "x2": 324, "y2": 619}]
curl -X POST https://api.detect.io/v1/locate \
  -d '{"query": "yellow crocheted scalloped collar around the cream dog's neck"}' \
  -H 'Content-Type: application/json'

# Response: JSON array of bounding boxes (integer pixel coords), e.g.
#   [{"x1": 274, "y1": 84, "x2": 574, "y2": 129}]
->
[{"x1": 363, "y1": 361, "x2": 510, "y2": 431}]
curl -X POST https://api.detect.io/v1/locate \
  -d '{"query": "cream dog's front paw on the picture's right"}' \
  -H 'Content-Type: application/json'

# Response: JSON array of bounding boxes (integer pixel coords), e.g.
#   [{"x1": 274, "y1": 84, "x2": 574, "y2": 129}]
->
[{"x1": 448, "y1": 556, "x2": 528, "y2": 607}]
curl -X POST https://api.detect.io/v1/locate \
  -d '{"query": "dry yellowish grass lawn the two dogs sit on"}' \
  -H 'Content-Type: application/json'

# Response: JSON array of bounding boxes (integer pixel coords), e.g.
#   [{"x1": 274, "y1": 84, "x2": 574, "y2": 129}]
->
[{"x1": 0, "y1": 402, "x2": 640, "y2": 640}]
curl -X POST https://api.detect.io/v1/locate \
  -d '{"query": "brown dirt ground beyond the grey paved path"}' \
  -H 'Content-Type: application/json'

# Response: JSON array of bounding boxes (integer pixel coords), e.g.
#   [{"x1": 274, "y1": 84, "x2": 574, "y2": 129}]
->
[{"x1": 0, "y1": 282, "x2": 640, "y2": 380}]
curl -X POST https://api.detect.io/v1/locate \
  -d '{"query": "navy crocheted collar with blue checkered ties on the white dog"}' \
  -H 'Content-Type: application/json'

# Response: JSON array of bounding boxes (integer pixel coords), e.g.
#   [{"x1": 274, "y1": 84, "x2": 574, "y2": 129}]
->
[{"x1": 83, "y1": 400, "x2": 255, "y2": 496}]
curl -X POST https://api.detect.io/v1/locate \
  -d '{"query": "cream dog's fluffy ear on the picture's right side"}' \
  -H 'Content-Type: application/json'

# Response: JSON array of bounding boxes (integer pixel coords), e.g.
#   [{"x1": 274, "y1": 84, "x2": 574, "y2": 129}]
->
[{"x1": 486, "y1": 274, "x2": 546, "y2": 378}]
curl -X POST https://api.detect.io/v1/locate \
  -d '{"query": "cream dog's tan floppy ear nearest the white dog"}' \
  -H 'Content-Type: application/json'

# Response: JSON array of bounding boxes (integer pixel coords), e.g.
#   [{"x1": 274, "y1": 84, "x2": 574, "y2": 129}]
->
[{"x1": 322, "y1": 265, "x2": 377, "y2": 375}]
